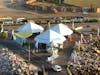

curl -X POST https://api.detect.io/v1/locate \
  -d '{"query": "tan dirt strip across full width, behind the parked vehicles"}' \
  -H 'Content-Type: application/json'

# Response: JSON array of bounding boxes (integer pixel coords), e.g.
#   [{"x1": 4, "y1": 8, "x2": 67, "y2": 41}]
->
[{"x1": 0, "y1": 0, "x2": 100, "y2": 18}]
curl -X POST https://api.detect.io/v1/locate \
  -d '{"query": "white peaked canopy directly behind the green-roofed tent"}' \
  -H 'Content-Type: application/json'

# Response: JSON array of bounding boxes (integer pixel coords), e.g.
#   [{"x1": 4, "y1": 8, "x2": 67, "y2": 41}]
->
[{"x1": 17, "y1": 22, "x2": 44, "y2": 33}]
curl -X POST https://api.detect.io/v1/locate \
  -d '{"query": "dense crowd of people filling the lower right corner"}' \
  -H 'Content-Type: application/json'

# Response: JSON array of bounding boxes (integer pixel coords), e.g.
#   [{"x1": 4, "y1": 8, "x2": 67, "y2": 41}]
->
[{"x1": 69, "y1": 38, "x2": 100, "y2": 75}]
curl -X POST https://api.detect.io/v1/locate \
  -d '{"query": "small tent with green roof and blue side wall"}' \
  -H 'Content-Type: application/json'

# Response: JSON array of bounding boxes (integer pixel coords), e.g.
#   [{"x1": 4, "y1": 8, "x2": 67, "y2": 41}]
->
[{"x1": 13, "y1": 31, "x2": 32, "y2": 45}]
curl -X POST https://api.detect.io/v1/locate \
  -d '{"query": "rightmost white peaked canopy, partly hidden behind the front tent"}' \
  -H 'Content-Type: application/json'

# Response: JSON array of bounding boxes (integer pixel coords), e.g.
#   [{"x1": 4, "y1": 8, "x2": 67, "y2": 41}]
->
[{"x1": 50, "y1": 23, "x2": 73, "y2": 36}]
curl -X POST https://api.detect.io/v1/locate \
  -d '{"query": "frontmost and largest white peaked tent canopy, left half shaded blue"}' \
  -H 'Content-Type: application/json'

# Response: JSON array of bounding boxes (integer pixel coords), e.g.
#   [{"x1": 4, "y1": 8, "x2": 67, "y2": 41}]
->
[{"x1": 34, "y1": 29, "x2": 66, "y2": 44}]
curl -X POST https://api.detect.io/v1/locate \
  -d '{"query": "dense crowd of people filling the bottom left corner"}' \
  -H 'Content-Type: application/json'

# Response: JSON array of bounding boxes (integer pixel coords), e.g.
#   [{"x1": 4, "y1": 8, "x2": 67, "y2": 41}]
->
[{"x1": 0, "y1": 47, "x2": 37, "y2": 75}]
